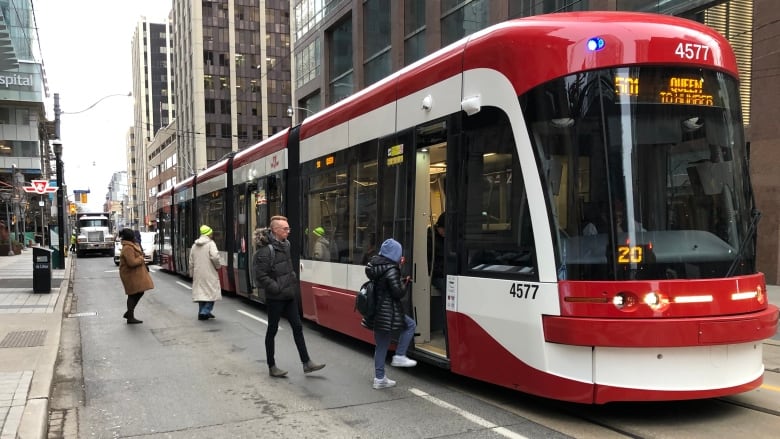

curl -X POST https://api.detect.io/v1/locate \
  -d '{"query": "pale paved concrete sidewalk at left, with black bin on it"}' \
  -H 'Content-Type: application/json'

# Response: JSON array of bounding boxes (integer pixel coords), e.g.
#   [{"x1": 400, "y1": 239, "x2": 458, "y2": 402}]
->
[{"x1": 0, "y1": 249, "x2": 73, "y2": 439}]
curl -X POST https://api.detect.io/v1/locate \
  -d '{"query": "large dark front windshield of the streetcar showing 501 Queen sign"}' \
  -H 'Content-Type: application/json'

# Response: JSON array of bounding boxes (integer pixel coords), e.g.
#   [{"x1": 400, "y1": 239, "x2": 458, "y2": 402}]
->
[{"x1": 520, "y1": 67, "x2": 755, "y2": 280}]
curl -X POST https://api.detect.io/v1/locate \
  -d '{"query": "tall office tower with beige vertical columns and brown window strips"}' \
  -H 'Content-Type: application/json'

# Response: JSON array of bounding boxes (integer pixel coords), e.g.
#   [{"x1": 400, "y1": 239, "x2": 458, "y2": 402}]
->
[{"x1": 171, "y1": 0, "x2": 291, "y2": 179}]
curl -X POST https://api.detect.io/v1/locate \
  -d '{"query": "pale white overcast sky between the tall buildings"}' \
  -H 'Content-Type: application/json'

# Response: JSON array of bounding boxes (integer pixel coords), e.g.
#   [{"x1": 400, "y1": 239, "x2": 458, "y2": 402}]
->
[{"x1": 33, "y1": 0, "x2": 171, "y2": 209}]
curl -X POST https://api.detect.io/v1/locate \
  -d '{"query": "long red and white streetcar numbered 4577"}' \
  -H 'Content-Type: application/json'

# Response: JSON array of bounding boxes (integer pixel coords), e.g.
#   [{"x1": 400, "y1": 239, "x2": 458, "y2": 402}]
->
[{"x1": 158, "y1": 12, "x2": 778, "y2": 404}]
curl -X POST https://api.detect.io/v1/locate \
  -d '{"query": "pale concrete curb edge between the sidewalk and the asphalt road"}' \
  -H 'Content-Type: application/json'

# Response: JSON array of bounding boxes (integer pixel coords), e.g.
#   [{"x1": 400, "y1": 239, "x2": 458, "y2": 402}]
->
[{"x1": 16, "y1": 257, "x2": 73, "y2": 439}]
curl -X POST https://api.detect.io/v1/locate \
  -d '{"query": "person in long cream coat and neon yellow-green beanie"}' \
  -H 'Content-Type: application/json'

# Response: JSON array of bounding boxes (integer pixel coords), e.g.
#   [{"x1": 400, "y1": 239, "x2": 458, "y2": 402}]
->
[{"x1": 189, "y1": 225, "x2": 222, "y2": 320}]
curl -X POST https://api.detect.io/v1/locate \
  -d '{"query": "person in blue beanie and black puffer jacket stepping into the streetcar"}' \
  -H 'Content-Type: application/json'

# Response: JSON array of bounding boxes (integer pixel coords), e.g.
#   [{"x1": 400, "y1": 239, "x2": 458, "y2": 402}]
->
[{"x1": 363, "y1": 238, "x2": 417, "y2": 389}]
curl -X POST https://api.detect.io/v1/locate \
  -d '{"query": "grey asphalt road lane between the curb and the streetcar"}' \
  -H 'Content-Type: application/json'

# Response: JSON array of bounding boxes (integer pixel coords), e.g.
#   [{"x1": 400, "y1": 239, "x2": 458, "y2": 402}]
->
[{"x1": 51, "y1": 257, "x2": 569, "y2": 438}]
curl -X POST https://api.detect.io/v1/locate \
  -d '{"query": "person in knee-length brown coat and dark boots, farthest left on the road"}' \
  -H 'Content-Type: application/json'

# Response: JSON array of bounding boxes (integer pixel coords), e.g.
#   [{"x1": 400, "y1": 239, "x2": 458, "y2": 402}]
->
[{"x1": 119, "y1": 229, "x2": 154, "y2": 325}]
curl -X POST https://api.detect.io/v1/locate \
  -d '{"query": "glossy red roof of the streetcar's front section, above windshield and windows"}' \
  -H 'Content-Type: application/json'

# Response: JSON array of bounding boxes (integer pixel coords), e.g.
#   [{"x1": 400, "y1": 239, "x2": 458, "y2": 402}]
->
[{"x1": 300, "y1": 11, "x2": 738, "y2": 139}]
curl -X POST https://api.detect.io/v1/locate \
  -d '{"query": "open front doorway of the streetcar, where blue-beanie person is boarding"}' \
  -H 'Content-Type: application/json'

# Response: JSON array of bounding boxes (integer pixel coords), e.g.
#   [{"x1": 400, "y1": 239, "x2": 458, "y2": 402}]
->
[{"x1": 412, "y1": 120, "x2": 447, "y2": 358}]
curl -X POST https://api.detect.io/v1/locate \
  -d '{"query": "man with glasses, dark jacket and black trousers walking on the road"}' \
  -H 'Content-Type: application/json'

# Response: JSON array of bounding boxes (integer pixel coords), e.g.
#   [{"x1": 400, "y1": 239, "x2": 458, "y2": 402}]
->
[{"x1": 252, "y1": 216, "x2": 325, "y2": 378}]
